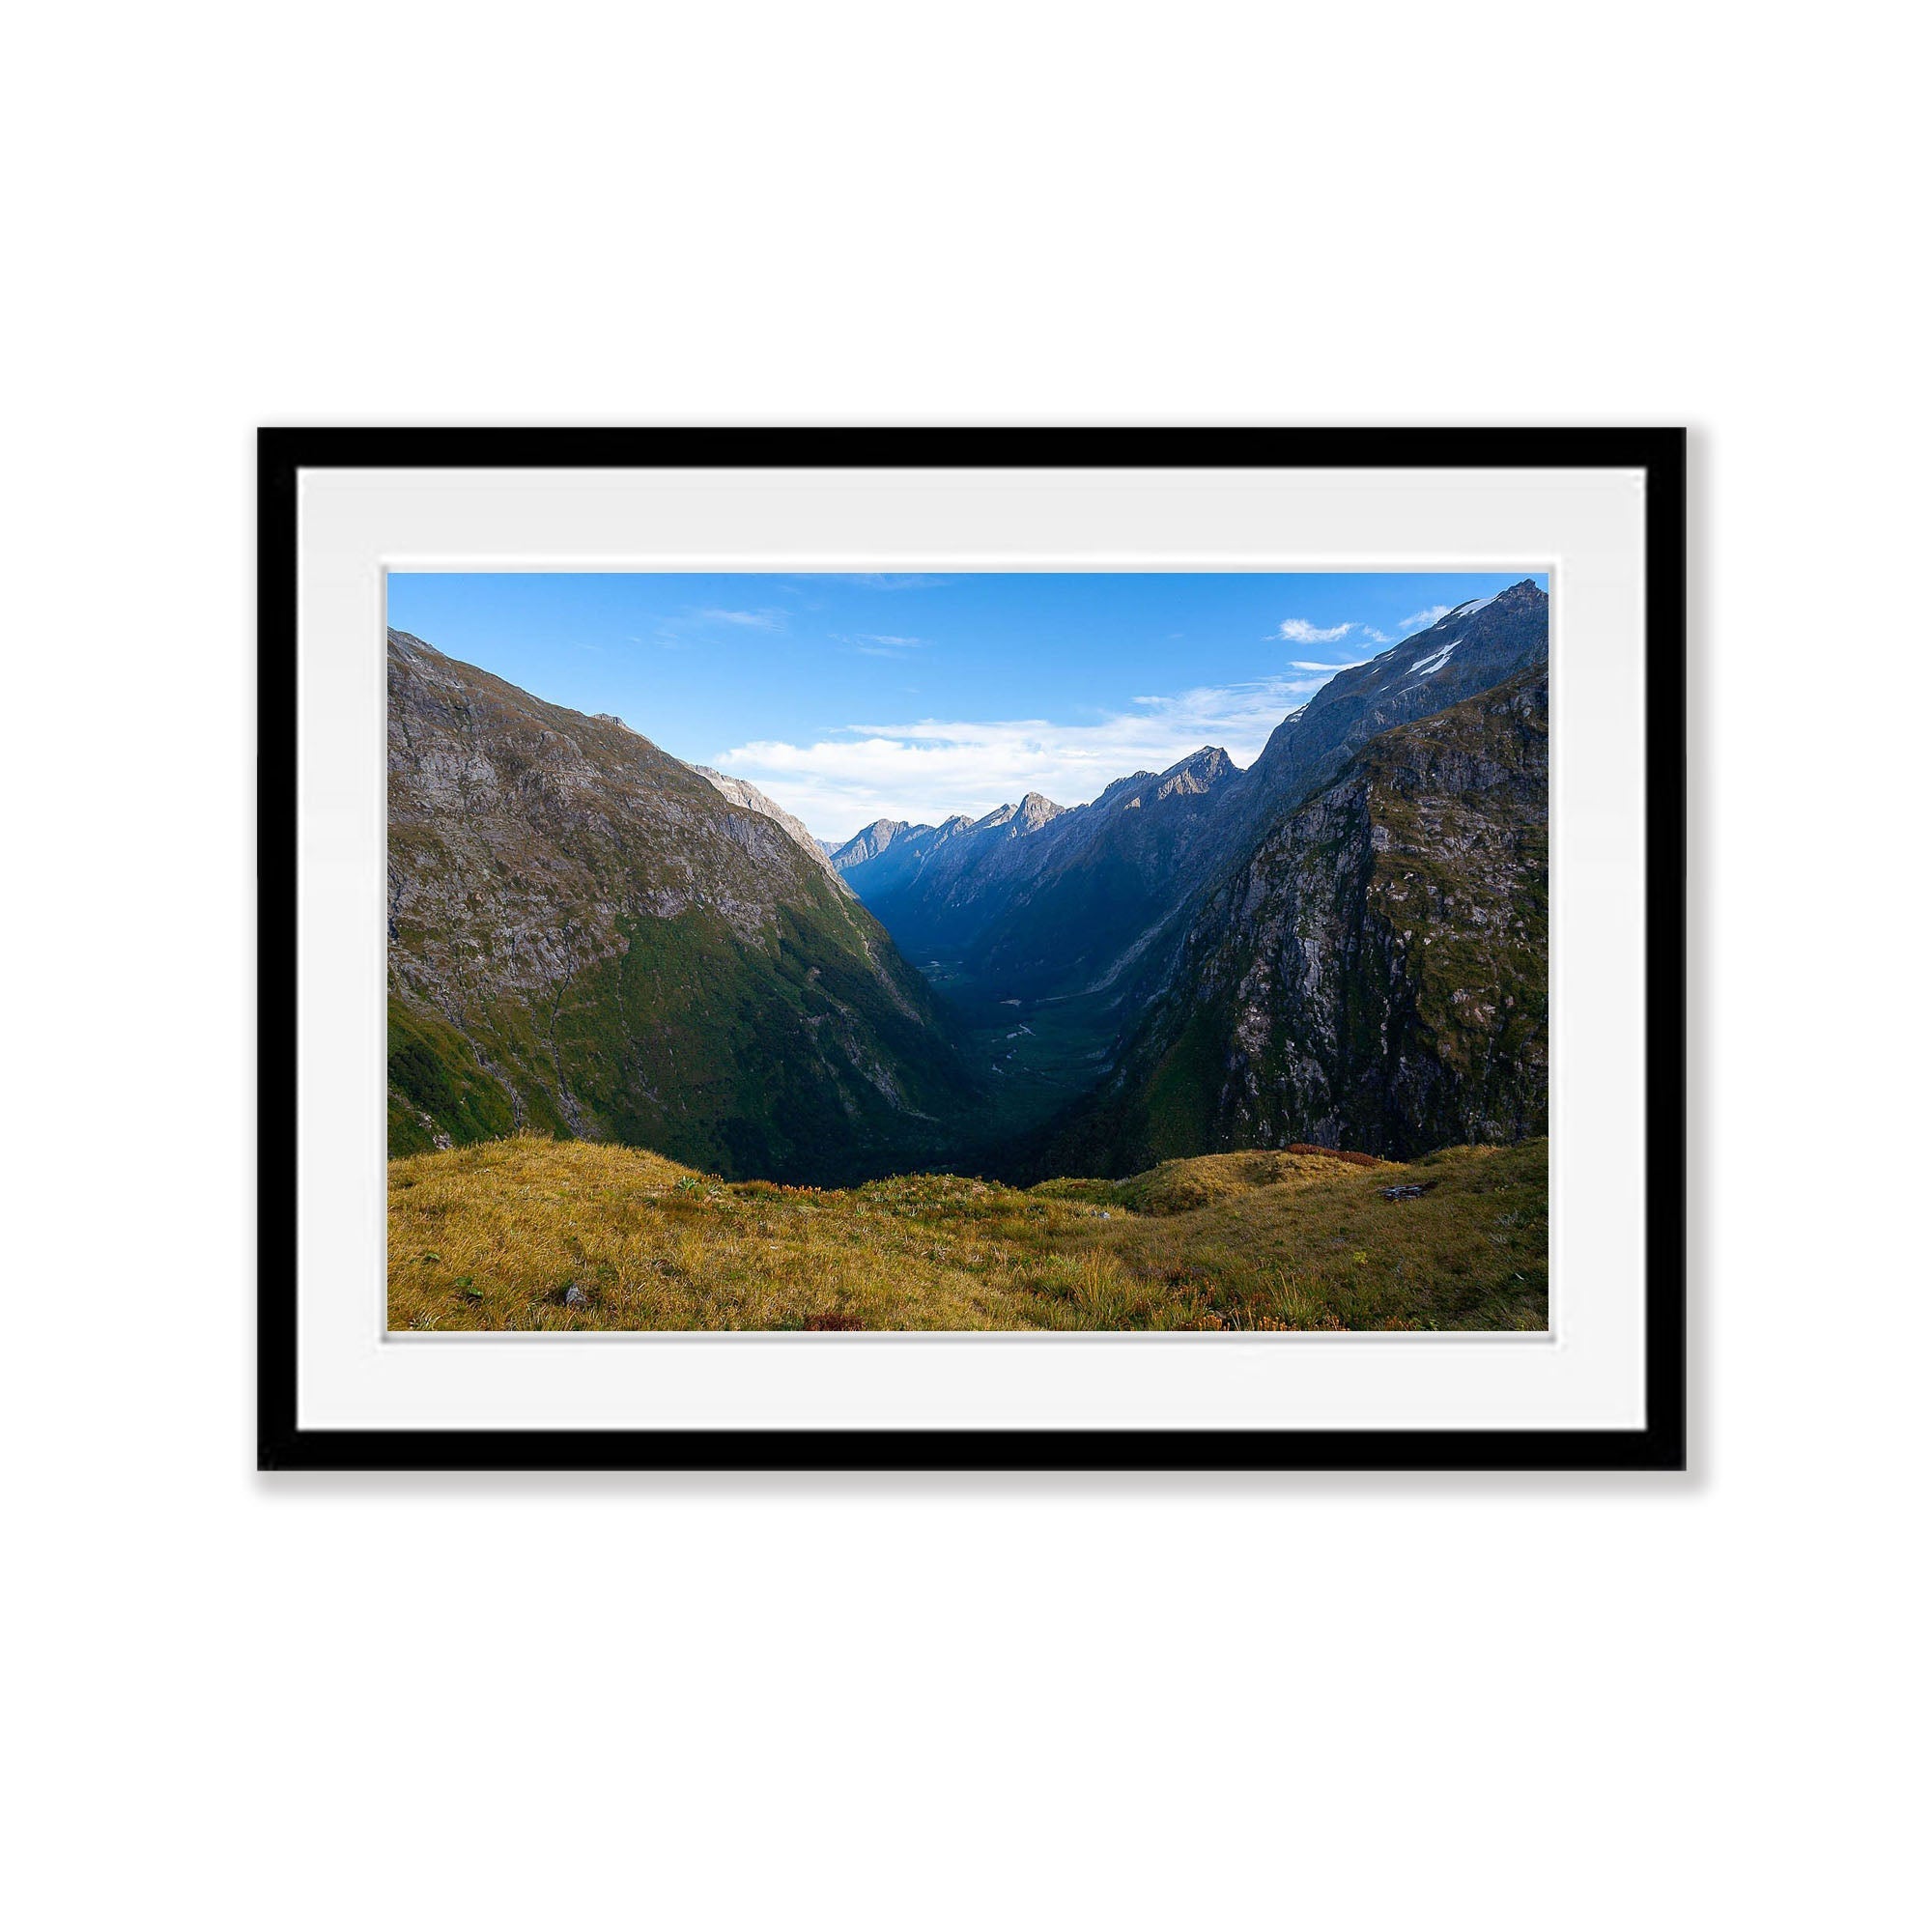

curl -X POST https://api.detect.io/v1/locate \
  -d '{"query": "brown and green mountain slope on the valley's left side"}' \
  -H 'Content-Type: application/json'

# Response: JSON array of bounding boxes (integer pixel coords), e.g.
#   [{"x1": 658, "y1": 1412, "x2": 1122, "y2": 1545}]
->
[{"x1": 388, "y1": 632, "x2": 972, "y2": 1184}]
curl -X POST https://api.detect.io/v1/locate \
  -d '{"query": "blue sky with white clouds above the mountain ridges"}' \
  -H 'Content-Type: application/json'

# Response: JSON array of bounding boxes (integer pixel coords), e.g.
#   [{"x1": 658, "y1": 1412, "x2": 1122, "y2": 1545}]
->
[{"x1": 388, "y1": 570, "x2": 1549, "y2": 838}]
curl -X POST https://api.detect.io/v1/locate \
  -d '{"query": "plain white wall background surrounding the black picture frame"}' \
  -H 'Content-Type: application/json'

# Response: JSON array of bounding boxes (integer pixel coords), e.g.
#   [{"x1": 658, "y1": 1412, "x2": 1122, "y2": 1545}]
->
[{"x1": 0, "y1": 0, "x2": 1932, "y2": 1932}]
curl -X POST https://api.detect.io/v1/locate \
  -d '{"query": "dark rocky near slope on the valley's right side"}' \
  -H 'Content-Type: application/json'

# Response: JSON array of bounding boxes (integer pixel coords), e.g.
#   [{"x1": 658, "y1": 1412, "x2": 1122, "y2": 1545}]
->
[{"x1": 1030, "y1": 653, "x2": 1549, "y2": 1175}]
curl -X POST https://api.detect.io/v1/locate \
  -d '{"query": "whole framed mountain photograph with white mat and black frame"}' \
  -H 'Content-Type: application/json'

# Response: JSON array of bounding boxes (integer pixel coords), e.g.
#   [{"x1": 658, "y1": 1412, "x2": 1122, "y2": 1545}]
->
[{"x1": 259, "y1": 429, "x2": 1685, "y2": 1470}]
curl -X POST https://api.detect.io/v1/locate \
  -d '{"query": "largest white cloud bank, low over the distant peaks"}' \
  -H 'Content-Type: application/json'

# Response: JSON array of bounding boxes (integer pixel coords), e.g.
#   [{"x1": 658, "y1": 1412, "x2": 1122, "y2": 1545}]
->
[{"x1": 705, "y1": 667, "x2": 1331, "y2": 838}]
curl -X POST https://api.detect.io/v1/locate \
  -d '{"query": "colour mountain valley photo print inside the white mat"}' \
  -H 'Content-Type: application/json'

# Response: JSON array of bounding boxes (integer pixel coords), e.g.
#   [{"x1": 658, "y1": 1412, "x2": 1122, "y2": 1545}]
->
[{"x1": 386, "y1": 568, "x2": 1551, "y2": 1335}]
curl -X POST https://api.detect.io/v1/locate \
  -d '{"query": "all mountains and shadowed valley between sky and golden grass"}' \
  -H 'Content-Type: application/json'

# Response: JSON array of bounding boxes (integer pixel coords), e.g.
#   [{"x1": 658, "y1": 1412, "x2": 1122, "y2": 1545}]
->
[{"x1": 390, "y1": 580, "x2": 1548, "y2": 1184}]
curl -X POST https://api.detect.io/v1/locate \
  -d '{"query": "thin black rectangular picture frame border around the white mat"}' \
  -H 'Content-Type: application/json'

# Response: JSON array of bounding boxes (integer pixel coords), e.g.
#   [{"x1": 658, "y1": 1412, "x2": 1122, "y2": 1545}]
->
[{"x1": 255, "y1": 427, "x2": 1687, "y2": 1470}]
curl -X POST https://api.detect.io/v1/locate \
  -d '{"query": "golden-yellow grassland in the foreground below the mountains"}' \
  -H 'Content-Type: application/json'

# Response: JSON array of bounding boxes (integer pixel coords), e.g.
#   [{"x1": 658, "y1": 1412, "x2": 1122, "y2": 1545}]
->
[{"x1": 388, "y1": 1136, "x2": 1549, "y2": 1331}]
